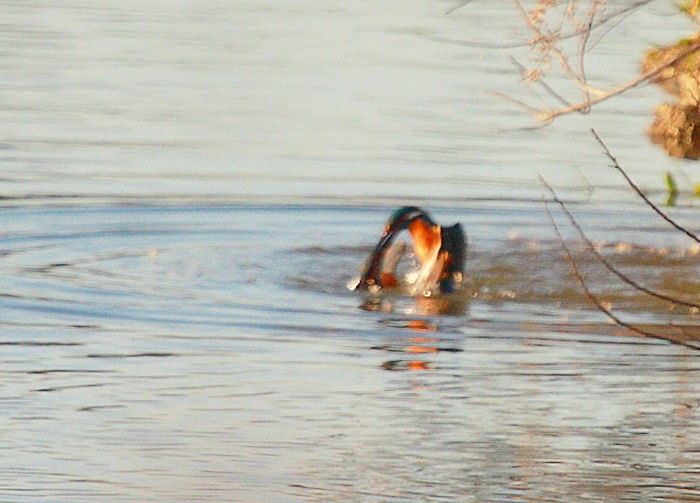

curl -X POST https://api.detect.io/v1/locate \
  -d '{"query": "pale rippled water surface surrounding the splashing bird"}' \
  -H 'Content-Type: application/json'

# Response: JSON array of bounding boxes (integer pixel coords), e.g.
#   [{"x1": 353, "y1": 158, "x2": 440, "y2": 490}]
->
[{"x1": 0, "y1": 0, "x2": 700, "y2": 502}]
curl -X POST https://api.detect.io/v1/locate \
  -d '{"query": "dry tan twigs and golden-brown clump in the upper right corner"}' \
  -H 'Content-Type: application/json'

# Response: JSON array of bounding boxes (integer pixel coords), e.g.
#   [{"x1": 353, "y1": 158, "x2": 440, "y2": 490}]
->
[{"x1": 494, "y1": 0, "x2": 700, "y2": 135}]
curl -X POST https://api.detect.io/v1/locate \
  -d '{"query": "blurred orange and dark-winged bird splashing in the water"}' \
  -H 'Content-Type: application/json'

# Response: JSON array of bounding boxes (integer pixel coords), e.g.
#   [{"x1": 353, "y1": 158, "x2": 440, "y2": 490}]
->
[{"x1": 353, "y1": 206, "x2": 467, "y2": 295}]
